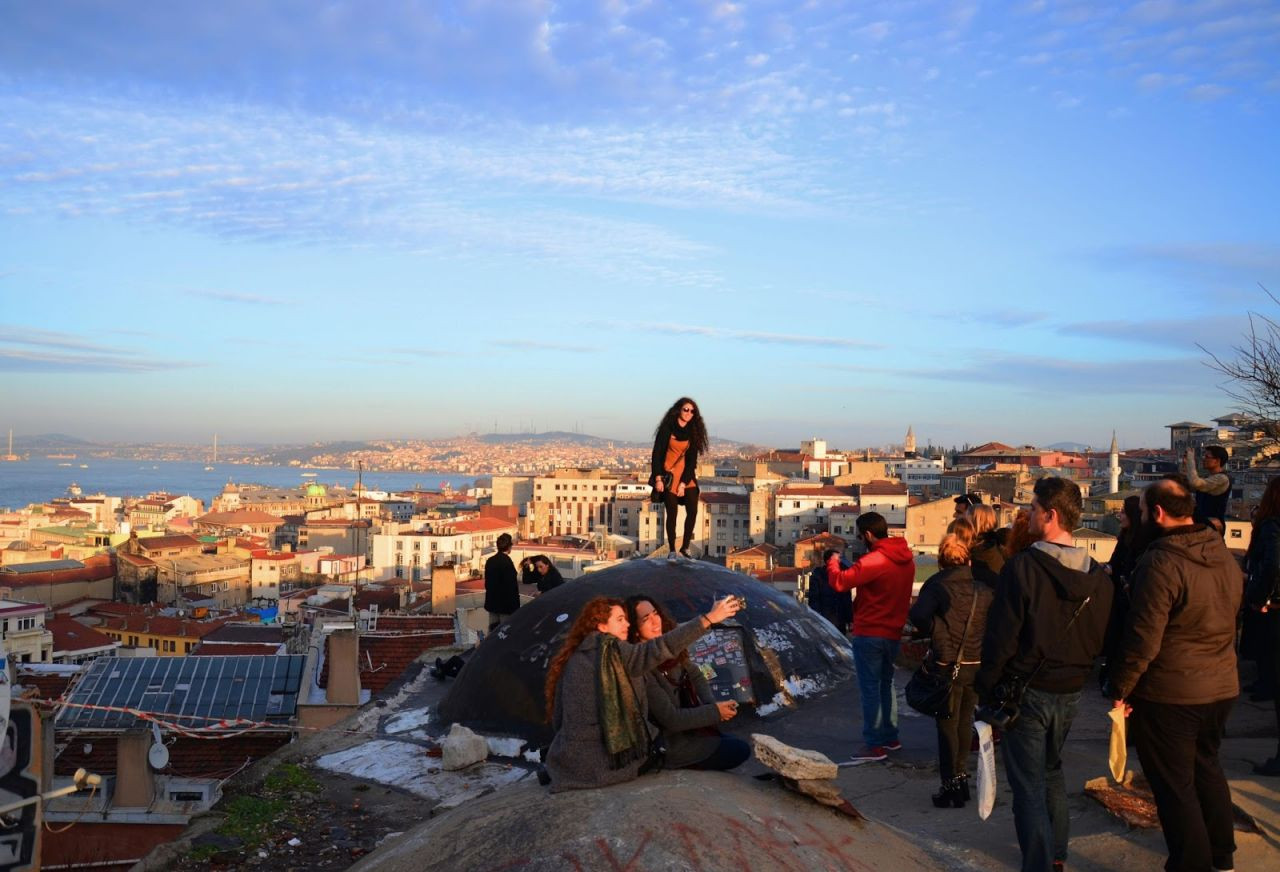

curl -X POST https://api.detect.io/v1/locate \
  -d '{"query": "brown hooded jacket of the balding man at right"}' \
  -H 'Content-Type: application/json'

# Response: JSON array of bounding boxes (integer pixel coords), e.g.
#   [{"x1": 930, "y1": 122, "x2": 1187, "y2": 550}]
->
[{"x1": 1110, "y1": 524, "x2": 1242, "y2": 706}]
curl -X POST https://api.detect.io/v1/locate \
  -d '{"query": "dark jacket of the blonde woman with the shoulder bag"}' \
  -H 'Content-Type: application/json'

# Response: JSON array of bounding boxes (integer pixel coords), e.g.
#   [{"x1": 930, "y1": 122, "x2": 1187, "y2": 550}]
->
[{"x1": 908, "y1": 566, "x2": 996, "y2": 666}]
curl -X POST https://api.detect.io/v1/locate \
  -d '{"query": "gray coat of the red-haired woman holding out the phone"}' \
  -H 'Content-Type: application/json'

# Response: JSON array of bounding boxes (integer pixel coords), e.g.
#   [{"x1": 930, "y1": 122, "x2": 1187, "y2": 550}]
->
[{"x1": 545, "y1": 617, "x2": 705, "y2": 793}]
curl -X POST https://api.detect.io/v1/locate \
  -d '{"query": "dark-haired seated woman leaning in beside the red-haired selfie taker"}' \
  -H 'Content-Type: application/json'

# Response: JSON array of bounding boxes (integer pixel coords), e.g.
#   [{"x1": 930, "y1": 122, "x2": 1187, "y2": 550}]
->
[{"x1": 627, "y1": 595, "x2": 751, "y2": 770}]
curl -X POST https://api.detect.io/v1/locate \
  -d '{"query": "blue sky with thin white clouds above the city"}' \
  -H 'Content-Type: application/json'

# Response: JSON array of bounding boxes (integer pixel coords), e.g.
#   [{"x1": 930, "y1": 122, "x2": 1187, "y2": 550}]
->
[{"x1": 0, "y1": 0, "x2": 1280, "y2": 448}]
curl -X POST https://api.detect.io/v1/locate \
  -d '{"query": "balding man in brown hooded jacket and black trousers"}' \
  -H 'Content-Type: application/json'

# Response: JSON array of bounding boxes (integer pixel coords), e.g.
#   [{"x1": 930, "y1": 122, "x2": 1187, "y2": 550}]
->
[{"x1": 1110, "y1": 479, "x2": 1242, "y2": 871}]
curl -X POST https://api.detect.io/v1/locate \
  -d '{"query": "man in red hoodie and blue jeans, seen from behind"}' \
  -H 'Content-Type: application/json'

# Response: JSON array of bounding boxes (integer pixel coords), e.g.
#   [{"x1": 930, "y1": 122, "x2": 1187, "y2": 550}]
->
[{"x1": 827, "y1": 512, "x2": 915, "y2": 763}]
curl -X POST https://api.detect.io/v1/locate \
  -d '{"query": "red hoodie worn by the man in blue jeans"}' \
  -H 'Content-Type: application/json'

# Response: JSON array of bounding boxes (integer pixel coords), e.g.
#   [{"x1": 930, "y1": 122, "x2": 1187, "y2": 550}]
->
[{"x1": 827, "y1": 537, "x2": 915, "y2": 639}]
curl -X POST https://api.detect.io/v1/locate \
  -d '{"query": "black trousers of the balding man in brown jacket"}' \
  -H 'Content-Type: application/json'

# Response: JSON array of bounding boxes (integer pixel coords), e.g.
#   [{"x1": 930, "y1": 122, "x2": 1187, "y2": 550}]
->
[{"x1": 1129, "y1": 699, "x2": 1235, "y2": 872}]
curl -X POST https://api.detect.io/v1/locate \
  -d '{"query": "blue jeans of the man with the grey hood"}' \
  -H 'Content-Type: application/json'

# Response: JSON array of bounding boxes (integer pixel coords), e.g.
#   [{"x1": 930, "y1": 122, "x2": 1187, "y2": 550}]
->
[{"x1": 1001, "y1": 688, "x2": 1080, "y2": 872}]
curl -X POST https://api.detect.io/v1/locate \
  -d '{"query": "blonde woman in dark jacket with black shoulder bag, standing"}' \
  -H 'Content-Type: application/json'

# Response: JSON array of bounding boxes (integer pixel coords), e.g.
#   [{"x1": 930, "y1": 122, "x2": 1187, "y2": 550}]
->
[{"x1": 909, "y1": 533, "x2": 995, "y2": 808}]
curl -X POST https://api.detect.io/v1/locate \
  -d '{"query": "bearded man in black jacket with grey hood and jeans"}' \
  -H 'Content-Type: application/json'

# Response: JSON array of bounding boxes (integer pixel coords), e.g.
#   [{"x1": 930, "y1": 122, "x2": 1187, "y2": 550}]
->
[{"x1": 975, "y1": 476, "x2": 1114, "y2": 872}]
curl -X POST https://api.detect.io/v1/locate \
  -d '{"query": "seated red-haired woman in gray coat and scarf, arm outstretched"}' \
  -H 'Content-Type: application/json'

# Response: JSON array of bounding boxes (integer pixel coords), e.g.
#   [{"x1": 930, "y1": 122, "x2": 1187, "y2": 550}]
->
[{"x1": 545, "y1": 597, "x2": 740, "y2": 793}]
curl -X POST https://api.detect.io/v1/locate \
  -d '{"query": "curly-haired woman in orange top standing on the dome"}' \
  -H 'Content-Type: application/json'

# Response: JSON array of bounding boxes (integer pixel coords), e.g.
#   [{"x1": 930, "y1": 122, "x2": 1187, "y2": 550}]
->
[{"x1": 649, "y1": 397, "x2": 708, "y2": 560}]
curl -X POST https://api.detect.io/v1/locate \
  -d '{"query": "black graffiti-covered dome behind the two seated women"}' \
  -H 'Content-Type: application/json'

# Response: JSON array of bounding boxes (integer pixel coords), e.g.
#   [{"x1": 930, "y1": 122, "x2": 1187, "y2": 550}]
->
[{"x1": 439, "y1": 560, "x2": 854, "y2": 743}]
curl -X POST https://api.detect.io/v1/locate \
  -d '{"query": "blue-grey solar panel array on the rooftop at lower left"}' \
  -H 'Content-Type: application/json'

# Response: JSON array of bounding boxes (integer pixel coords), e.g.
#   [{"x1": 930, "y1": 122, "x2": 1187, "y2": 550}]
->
[{"x1": 55, "y1": 654, "x2": 306, "y2": 730}]
